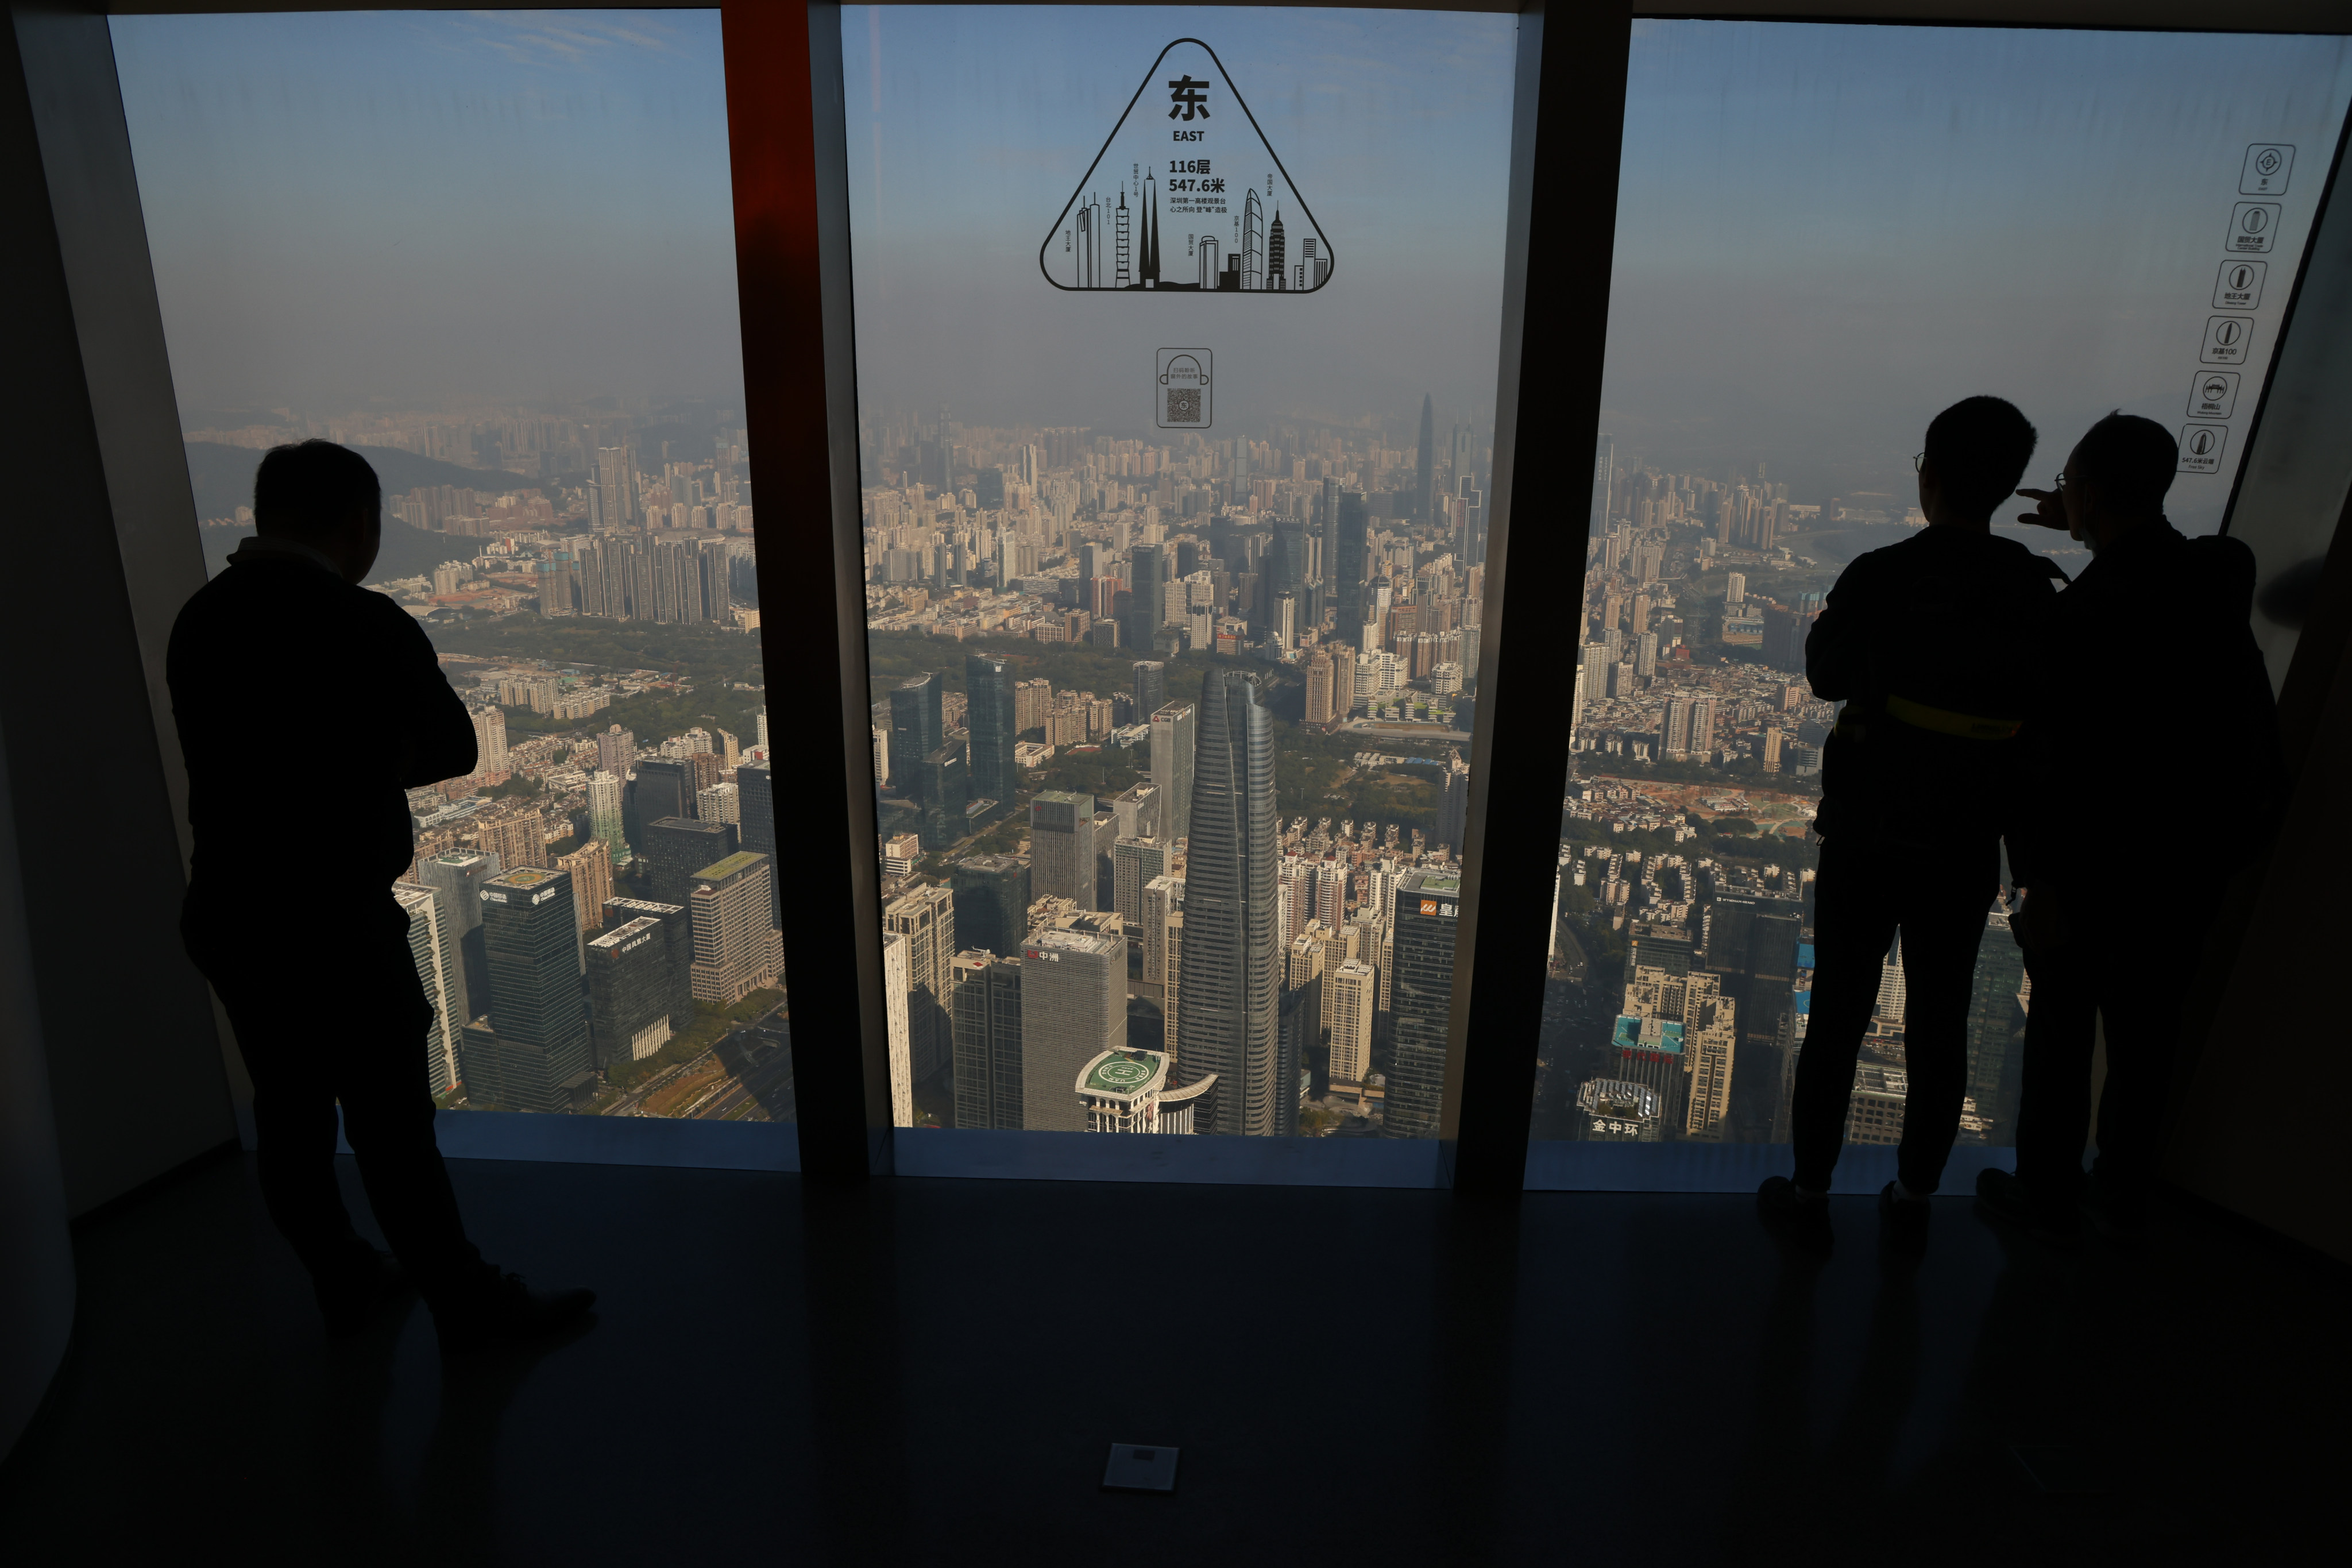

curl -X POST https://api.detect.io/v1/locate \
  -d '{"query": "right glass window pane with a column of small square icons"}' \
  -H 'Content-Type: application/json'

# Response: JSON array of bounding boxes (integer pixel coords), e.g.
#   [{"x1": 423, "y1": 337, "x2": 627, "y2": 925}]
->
[{"x1": 1529, "y1": 21, "x2": 2352, "y2": 1187}]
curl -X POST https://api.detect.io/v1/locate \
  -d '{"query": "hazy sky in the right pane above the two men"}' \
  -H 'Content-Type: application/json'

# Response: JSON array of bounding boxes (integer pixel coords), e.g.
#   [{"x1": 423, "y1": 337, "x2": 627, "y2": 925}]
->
[{"x1": 1604, "y1": 21, "x2": 2352, "y2": 527}]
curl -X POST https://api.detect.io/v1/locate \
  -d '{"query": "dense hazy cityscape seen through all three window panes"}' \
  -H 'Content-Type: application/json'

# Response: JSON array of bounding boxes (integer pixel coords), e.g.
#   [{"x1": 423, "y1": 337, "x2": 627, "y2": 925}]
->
[{"x1": 188, "y1": 388, "x2": 2027, "y2": 1161}]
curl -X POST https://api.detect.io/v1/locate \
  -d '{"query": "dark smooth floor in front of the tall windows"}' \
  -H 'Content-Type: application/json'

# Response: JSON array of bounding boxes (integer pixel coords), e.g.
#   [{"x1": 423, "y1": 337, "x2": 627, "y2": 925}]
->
[{"x1": 0, "y1": 1161, "x2": 2352, "y2": 1568}]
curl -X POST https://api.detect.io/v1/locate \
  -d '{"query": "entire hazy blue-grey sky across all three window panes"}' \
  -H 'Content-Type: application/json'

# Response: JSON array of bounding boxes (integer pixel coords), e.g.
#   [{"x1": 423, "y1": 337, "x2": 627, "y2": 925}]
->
[{"x1": 113, "y1": 7, "x2": 2352, "y2": 527}]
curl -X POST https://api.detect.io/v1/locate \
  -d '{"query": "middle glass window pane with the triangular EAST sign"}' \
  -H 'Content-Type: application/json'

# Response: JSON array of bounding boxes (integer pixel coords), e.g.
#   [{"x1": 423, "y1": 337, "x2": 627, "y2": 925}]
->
[{"x1": 842, "y1": 7, "x2": 1515, "y2": 1147}]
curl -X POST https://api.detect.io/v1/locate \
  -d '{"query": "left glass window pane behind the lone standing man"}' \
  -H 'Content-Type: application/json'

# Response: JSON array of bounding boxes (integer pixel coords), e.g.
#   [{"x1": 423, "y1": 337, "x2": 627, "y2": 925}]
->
[{"x1": 113, "y1": 9, "x2": 793, "y2": 1142}]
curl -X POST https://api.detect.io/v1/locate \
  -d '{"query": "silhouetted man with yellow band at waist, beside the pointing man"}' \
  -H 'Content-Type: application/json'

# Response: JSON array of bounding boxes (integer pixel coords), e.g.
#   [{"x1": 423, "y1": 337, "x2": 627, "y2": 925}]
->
[{"x1": 1757, "y1": 397, "x2": 2058, "y2": 1250}]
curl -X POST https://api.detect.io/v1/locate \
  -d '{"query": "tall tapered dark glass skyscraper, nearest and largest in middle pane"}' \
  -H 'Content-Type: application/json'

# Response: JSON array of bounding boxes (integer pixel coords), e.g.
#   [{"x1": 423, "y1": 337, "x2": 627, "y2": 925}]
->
[{"x1": 1171, "y1": 670, "x2": 1282, "y2": 1136}]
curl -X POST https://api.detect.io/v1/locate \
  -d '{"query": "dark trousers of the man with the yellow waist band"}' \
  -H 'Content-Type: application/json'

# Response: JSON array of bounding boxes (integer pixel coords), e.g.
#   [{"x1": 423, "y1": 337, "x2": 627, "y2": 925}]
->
[{"x1": 1790, "y1": 837, "x2": 2002, "y2": 1192}]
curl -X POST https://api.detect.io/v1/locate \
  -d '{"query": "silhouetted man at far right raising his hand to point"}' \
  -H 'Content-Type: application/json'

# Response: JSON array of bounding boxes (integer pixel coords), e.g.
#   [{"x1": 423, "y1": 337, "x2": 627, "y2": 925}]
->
[{"x1": 1976, "y1": 414, "x2": 2284, "y2": 1241}]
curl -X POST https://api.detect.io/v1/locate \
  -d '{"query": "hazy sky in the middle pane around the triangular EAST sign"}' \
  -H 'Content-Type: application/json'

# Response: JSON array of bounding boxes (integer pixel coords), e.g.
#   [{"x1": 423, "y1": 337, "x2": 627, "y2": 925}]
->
[{"x1": 842, "y1": 5, "x2": 1515, "y2": 439}]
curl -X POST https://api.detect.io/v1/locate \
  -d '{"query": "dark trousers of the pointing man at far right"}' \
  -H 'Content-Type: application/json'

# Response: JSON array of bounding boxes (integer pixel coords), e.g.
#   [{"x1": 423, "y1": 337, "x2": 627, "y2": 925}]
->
[{"x1": 2018, "y1": 891, "x2": 2208, "y2": 1225}]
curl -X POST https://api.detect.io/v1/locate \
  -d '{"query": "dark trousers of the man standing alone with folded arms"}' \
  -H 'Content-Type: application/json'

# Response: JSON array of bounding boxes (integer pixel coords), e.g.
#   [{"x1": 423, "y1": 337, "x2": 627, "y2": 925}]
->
[{"x1": 181, "y1": 895, "x2": 485, "y2": 1305}]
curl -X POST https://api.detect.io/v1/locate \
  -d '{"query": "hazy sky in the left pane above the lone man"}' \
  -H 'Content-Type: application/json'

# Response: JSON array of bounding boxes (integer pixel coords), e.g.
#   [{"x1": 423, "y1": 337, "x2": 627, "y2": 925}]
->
[{"x1": 110, "y1": 11, "x2": 743, "y2": 420}]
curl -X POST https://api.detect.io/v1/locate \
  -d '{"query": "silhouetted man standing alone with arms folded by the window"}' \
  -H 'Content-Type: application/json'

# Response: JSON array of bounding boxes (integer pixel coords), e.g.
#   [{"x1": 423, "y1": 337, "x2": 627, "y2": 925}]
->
[{"x1": 167, "y1": 442, "x2": 595, "y2": 1349}]
